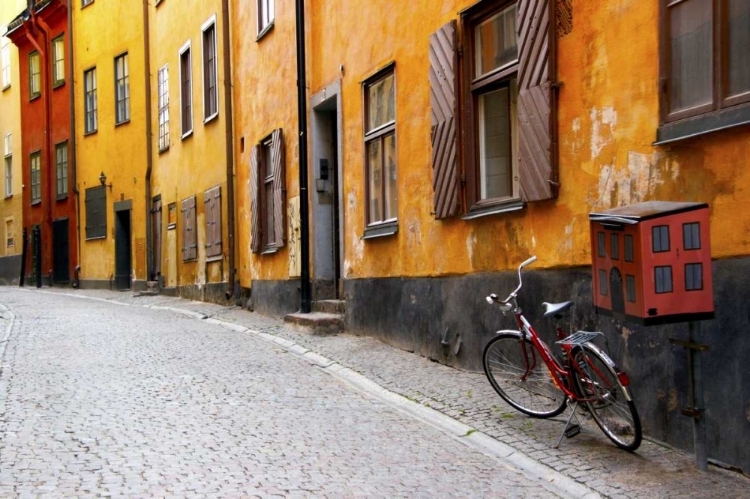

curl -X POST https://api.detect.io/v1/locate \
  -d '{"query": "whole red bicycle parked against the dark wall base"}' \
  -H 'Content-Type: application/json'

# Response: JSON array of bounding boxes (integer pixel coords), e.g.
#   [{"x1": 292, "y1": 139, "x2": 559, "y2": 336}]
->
[{"x1": 482, "y1": 256, "x2": 642, "y2": 451}]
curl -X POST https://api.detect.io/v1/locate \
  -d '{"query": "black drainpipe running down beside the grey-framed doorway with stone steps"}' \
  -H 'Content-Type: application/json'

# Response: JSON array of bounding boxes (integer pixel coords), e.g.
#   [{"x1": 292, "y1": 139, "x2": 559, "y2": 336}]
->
[{"x1": 295, "y1": 0, "x2": 311, "y2": 313}]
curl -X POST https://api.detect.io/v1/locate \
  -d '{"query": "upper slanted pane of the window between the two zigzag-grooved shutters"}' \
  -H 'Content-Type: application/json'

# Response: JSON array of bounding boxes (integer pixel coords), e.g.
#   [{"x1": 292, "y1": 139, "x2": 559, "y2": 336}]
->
[{"x1": 474, "y1": 4, "x2": 518, "y2": 78}]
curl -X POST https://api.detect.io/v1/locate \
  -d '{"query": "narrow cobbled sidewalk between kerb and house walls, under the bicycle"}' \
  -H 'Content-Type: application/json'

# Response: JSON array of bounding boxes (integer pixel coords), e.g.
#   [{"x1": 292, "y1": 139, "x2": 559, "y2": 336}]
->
[{"x1": 5, "y1": 289, "x2": 750, "y2": 498}]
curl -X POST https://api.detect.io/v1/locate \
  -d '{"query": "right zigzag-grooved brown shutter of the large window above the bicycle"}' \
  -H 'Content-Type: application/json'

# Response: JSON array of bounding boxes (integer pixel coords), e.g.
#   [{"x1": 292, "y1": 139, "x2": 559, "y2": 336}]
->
[{"x1": 517, "y1": 0, "x2": 557, "y2": 201}]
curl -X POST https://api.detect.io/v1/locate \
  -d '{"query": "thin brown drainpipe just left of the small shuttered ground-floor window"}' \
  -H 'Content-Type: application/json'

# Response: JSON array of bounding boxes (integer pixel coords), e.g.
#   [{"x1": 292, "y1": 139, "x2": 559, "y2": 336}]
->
[{"x1": 221, "y1": 0, "x2": 236, "y2": 300}]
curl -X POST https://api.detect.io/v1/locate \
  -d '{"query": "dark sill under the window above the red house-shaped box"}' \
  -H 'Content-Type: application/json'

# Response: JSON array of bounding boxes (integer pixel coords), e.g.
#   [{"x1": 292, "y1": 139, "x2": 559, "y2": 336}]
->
[{"x1": 653, "y1": 104, "x2": 750, "y2": 146}]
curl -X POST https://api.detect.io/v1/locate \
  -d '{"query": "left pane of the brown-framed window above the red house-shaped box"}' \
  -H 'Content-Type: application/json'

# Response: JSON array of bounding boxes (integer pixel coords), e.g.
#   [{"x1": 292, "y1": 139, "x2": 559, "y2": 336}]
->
[{"x1": 669, "y1": 0, "x2": 713, "y2": 112}]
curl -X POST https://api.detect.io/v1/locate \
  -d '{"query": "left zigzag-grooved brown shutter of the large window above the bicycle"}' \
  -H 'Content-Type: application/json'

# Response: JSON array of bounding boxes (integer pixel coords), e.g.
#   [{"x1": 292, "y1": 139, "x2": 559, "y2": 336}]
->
[{"x1": 430, "y1": 21, "x2": 459, "y2": 218}]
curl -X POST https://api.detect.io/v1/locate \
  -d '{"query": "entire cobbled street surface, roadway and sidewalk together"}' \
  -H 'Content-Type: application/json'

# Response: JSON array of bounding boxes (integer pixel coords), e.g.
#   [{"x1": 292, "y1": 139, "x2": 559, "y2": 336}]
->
[{"x1": 0, "y1": 288, "x2": 750, "y2": 498}]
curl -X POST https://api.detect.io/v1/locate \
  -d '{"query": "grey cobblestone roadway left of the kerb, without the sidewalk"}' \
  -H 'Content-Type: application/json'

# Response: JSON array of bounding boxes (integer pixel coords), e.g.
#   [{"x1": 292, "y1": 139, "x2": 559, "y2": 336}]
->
[{"x1": 0, "y1": 288, "x2": 564, "y2": 498}]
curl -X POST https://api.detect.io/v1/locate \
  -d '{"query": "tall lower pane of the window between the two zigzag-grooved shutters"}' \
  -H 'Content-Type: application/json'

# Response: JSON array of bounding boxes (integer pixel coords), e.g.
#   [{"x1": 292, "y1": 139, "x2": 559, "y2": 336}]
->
[{"x1": 479, "y1": 88, "x2": 512, "y2": 199}]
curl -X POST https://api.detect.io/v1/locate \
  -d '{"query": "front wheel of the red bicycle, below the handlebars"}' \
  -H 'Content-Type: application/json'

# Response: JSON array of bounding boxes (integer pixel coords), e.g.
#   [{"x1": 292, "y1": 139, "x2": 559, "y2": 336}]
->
[{"x1": 482, "y1": 331, "x2": 567, "y2": 418}]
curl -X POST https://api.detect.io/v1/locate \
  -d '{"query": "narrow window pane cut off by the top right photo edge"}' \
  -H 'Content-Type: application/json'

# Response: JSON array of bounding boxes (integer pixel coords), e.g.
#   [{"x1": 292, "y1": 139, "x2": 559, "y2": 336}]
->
[{"x1": 727, "y1": 0, "x2": 750, "y2": 96}]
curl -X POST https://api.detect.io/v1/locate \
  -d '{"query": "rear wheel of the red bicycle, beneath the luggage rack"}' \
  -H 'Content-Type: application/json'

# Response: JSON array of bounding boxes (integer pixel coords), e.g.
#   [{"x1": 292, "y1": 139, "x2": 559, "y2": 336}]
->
[{"x1": 571, "y1": 344, "x2": 643, "y2": 452}]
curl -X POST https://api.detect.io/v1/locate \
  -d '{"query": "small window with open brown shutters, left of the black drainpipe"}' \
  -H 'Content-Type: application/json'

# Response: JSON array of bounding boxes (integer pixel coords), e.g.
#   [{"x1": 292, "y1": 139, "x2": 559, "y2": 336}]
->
[{"x1": 250, "y1": 129, "x2": 286, "y2": 253}]
